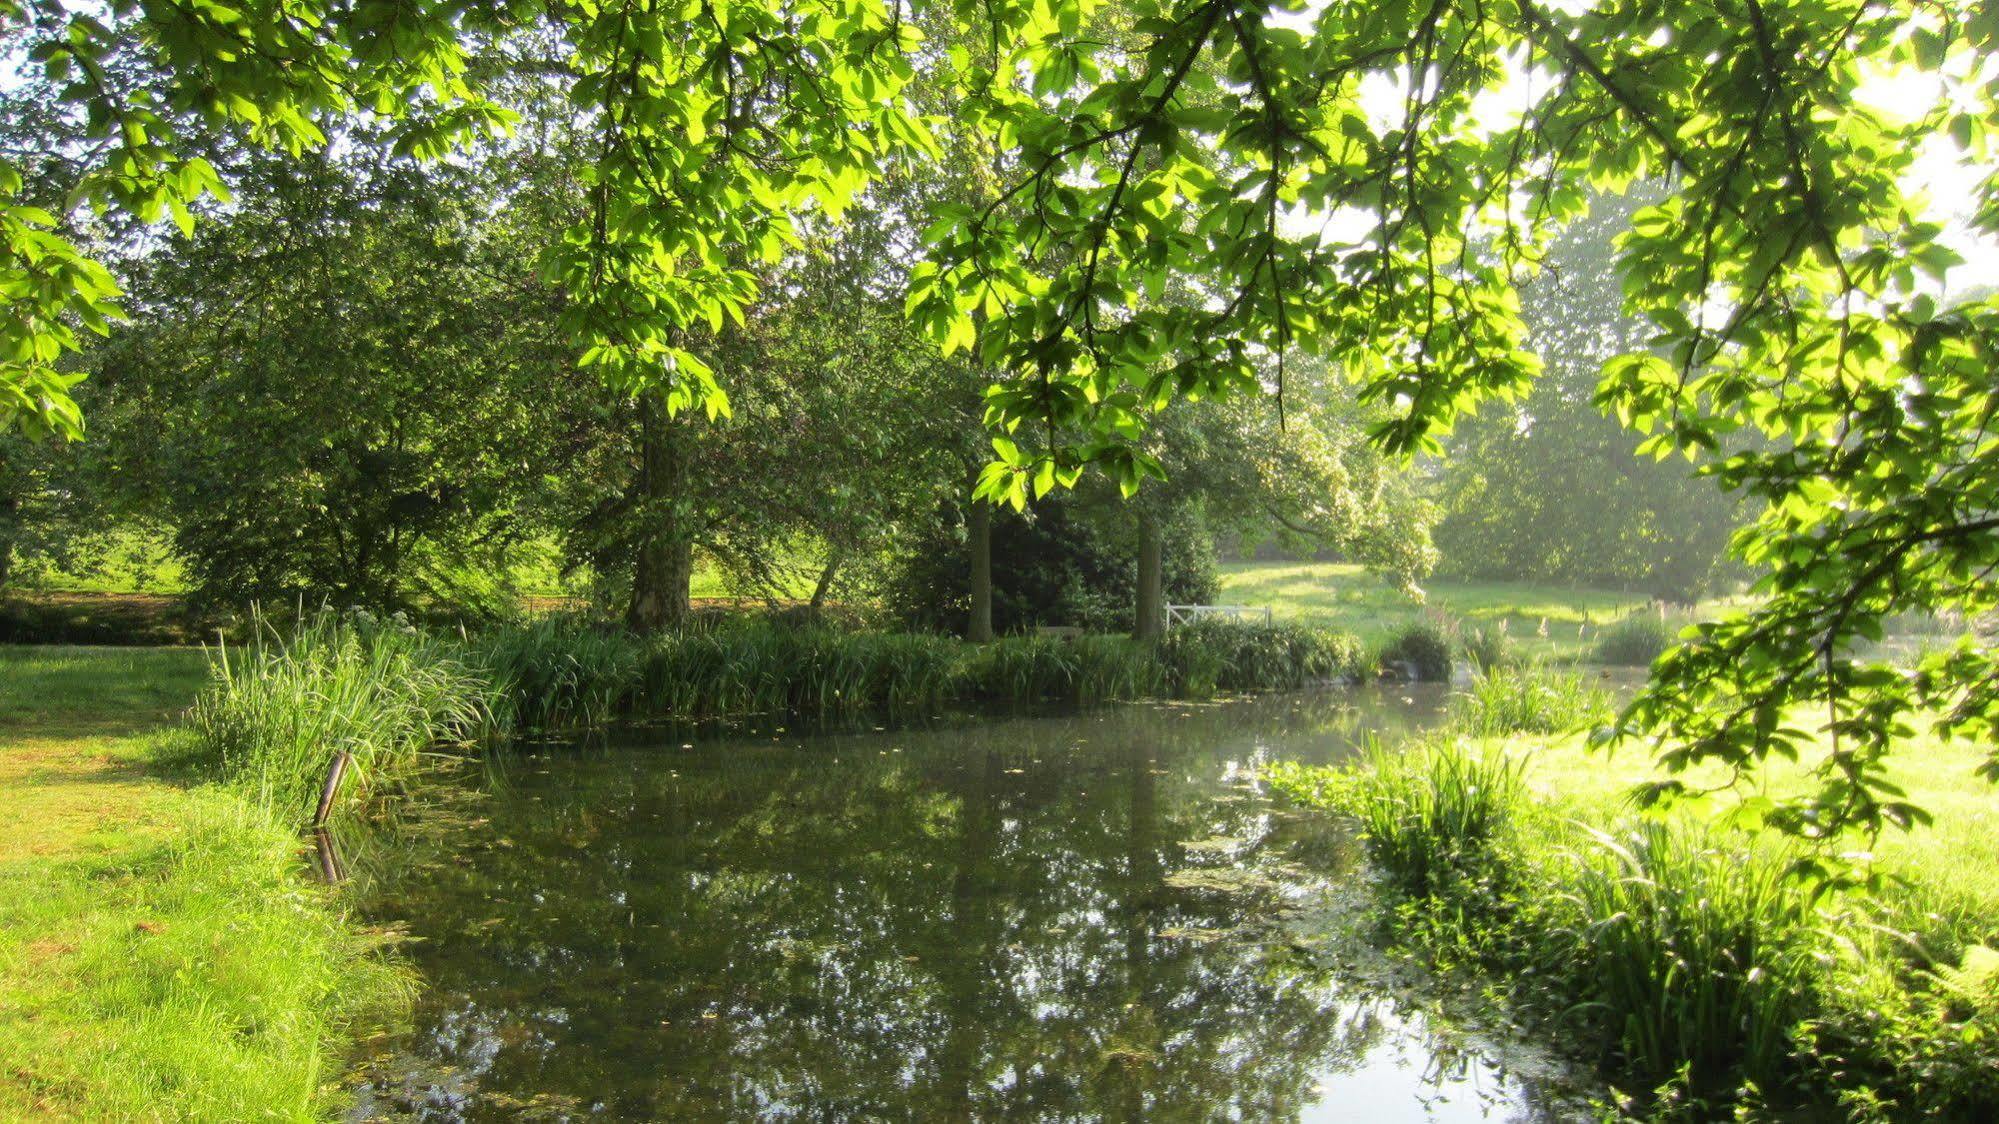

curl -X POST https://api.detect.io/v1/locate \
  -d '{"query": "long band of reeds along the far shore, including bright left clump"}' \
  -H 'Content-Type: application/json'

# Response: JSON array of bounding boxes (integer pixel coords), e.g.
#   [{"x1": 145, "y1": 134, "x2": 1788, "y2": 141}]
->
[{"x1": 188, "y1": 614, "x2": 1373, "y2": 814}]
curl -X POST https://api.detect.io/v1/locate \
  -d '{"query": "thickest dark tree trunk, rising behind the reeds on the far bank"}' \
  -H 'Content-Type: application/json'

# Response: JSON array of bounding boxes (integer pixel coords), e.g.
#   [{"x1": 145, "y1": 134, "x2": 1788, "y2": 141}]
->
[{"x1": 626, "y1": 396, "x2": 694, "y2": 632}]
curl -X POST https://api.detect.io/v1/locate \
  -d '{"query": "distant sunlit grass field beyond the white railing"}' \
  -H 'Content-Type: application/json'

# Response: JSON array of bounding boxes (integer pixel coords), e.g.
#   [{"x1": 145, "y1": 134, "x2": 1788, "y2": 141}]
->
[{"x1": 1221, "y1": 562, "x2": 1687, "y2": 654}]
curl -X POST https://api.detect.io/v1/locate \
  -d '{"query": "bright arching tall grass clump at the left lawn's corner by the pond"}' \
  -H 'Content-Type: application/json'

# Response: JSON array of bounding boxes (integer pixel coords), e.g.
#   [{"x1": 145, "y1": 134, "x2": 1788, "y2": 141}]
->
[{"x1": 188, "y1": 612, "x2": 500, "y2": 818}]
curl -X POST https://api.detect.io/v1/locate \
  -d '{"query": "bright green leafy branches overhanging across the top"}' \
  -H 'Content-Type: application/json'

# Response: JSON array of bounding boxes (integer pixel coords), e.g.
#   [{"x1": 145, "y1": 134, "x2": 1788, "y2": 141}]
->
[{"x1": 0, "y1": 0, "x2": 1999, "y2": 834}]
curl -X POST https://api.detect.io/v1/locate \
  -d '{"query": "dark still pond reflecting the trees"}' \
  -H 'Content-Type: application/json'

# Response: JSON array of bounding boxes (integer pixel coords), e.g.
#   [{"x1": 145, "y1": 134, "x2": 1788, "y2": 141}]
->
[{"x1": 346, "y1": 686, "x2": 1591, "y2": 1120}]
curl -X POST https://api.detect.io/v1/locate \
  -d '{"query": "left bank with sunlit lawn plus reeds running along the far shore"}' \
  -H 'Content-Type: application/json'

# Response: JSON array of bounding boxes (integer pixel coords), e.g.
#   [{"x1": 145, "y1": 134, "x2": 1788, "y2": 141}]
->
[{"x1": 0, "y1": 616, "x2": 1363, "y2": 1120}]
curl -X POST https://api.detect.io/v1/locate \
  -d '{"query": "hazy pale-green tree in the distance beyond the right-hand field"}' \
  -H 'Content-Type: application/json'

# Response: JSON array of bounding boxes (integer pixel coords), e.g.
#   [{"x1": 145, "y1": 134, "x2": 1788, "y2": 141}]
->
[{"x1": 1437, "y1": 198, "x2": 1745, "y2": 604}]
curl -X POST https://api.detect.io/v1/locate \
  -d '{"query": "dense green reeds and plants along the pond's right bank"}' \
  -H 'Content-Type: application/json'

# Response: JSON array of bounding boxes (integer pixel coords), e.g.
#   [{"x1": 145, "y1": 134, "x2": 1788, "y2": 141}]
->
[{"x1": 1269, "y1": 672, "x2": 1999, "y2": 1120}]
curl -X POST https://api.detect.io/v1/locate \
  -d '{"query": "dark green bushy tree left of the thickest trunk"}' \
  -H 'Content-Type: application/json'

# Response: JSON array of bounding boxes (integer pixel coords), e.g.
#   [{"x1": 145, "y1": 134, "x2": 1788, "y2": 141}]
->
[{"x1": 98, "y1": 150, "x2": 564, "y2": 606}]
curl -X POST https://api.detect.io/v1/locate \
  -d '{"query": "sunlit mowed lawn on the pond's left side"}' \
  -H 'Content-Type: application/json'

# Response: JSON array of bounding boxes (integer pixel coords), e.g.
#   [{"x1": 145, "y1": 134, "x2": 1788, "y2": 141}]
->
[{"x1": 0, "y1": 648, "x2": 410, "y2": 1120}]
